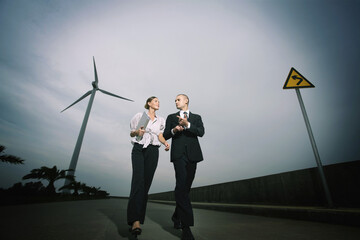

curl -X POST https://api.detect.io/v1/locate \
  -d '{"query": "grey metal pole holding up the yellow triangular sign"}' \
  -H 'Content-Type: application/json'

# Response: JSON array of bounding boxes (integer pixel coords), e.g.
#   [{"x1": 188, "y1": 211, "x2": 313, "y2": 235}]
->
[{"x1": 295, "y1": 88, "x2": 334, "y2": 208}]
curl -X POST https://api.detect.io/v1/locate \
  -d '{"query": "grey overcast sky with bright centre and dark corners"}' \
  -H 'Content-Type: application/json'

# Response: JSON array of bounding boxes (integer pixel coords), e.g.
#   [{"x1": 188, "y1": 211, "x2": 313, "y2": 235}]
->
[{"x1": 0, "y1": 0, "x2": 360, "y2": 196}]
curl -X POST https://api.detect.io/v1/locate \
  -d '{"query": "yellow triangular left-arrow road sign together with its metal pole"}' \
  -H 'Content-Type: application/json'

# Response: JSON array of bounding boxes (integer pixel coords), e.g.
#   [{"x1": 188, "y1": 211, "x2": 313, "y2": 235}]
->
[{"x1": 283, "y1": 68, "x2": 334, "y2": 208}]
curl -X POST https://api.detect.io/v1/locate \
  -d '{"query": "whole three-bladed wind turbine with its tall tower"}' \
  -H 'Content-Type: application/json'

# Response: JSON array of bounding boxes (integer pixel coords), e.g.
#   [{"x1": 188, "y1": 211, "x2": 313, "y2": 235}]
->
[{"x1": 61, "y1": 57, "x2": 133, "y2": 193}]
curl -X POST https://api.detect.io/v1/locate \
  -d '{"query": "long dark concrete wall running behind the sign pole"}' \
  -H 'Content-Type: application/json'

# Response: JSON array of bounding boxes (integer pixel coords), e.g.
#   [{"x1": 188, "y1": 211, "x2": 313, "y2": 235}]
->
[{"x1": 149, "y1": 161, "x2": 360, "y2": 207}]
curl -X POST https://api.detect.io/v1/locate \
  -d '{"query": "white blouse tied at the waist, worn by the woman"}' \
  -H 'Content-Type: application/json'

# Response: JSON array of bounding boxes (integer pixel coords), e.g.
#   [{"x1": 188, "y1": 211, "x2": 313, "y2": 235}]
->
[{"x1": 130, "y1": 112, "x2": 165, "y2": 148}]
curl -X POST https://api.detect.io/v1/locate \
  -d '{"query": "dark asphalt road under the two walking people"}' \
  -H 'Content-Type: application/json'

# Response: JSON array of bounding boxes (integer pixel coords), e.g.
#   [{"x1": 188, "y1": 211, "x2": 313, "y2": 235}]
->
[{"x1": 0, "y1": 199, "x2": 360, "y2": 240}]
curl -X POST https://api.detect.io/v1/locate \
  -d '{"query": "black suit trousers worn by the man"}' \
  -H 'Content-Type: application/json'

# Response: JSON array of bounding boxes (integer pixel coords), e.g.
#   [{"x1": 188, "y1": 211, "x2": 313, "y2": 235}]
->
[{"x1": 173, "y1": 155, "x2": 197, "y2": 227}]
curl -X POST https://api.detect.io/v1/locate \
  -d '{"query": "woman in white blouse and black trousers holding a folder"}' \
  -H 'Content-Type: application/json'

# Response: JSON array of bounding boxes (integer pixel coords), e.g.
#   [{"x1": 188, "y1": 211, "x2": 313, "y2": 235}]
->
[{"x1": 127, "y1": 96, "x2": 170, "y2": 235}]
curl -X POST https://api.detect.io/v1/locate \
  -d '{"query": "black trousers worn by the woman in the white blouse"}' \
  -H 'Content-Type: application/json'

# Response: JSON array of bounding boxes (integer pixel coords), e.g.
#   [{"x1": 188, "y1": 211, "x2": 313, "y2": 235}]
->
[{"x1": 127, "y1": 143, "x2": 159, "y2": 225}]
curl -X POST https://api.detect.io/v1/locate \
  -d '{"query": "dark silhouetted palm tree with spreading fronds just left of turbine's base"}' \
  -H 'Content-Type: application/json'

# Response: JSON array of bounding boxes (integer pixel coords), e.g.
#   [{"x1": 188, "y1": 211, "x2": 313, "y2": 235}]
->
[{"x1": 23, "y1": 166, "x2": 74, "y2": 194}]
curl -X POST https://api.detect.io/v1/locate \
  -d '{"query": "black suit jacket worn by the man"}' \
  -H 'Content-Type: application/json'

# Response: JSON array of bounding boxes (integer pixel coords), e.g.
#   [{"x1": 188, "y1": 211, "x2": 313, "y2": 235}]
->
[{"x1": 163, "y1": 112, "x2": 205, "y2": 162}]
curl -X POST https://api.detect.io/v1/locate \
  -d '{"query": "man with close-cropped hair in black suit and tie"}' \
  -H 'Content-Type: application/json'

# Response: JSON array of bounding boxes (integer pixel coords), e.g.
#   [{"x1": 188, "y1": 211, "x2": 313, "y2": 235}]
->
[{"x1": 163, "y1": 94, "x2": 205, "y2": 240}]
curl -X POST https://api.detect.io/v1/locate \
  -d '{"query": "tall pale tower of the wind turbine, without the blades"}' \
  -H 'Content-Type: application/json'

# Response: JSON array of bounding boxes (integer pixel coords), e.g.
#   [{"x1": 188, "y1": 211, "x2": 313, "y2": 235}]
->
[{"x1": 63, "y1": 88, "x2": 97, "y2": 193}]
